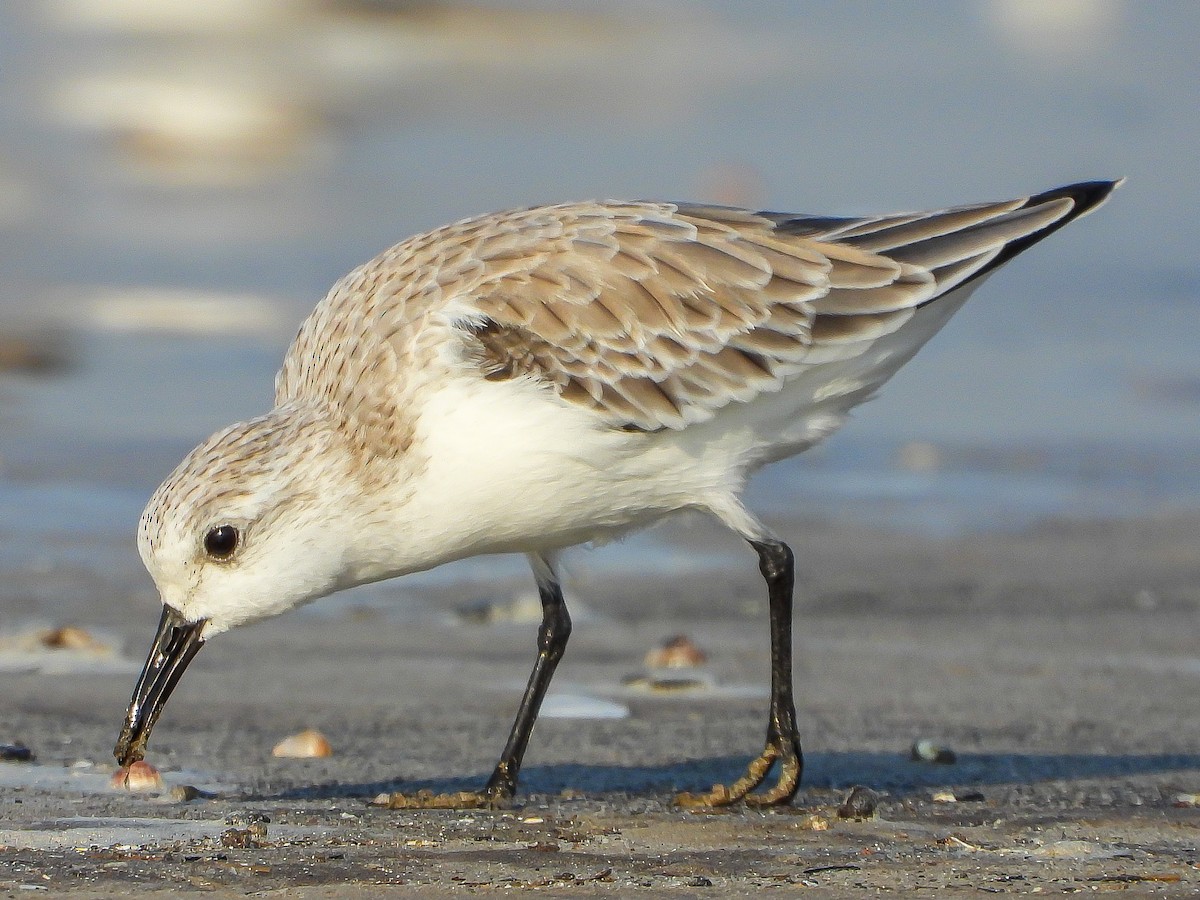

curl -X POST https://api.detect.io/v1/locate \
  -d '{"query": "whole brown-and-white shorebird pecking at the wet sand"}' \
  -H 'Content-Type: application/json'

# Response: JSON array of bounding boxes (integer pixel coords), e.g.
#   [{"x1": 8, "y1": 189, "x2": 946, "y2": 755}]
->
[{"x1": 115, "y1": 181, "x2": 1120, "y2": 806}]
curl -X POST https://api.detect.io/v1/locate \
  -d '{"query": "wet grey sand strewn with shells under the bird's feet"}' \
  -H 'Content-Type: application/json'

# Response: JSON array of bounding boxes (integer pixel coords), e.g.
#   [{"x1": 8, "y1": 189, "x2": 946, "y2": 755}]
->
[{"x1": 0, "y1": 515, "x2": 1200, "y2": 898}]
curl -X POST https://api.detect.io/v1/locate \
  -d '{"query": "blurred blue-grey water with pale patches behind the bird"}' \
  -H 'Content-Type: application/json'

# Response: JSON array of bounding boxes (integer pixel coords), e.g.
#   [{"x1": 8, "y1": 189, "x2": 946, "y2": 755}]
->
[{"x1": 0, "y1": 0, "x2": 1200, "y2": 600}]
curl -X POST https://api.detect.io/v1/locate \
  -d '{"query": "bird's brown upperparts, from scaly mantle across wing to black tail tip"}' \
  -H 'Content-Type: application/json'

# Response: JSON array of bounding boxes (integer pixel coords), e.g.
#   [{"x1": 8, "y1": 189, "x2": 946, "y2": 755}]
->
[{"x1": 276, "y1": 182, "x2": 1114, "y2": 446}]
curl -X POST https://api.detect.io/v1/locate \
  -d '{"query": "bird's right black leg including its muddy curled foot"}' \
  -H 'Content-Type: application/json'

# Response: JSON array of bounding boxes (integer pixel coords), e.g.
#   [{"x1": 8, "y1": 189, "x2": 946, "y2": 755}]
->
[{"x1": 676, "y1": 539, "x2": 804, "y2": 806}]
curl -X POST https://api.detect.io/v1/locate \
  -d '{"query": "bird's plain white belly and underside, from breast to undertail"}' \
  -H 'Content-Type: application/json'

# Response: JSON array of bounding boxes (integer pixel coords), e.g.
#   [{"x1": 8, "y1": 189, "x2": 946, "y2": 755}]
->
[{"x1": 374, "y1": 284, "x2": 974, "y2": 576}]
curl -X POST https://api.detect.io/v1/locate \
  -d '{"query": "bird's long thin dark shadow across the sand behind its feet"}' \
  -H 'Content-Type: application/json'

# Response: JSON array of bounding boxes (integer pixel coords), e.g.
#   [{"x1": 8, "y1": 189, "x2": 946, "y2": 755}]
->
[{"x1": 265, "y1": 751, "x2": 1200, "y2": 800}]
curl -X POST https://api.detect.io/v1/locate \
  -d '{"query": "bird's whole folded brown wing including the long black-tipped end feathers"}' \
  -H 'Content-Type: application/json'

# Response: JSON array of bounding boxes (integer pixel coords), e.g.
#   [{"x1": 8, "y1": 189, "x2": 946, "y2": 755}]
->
[{"x1": 451, "y1": 182, "x2": 1114, "y2": 431}]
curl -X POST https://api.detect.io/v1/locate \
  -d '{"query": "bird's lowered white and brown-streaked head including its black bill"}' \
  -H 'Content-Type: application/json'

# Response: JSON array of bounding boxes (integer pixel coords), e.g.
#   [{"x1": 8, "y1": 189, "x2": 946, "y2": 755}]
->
[{"x1": 114, "y1": 407, "x2": 360, "y2": 766}]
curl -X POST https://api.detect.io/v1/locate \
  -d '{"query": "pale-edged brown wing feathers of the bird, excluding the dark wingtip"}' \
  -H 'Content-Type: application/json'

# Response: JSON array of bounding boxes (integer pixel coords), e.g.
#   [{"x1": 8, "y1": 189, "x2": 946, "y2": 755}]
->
[{"x1": 467, "y1": 204, "x2": 934, "y2": 431}]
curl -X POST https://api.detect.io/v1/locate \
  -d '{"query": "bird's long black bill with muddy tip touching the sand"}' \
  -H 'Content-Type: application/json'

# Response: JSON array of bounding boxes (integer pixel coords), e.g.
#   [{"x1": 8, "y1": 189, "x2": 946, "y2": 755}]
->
[{"x1": 113, "y1": 605, "x2": 206, "y2": 766}]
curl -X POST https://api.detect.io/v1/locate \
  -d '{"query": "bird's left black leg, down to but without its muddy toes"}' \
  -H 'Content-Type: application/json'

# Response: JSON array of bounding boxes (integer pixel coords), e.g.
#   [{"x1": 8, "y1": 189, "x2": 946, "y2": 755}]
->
[{"x1": 484, "y1": 564, "x2": 571, "y2": 804}]
